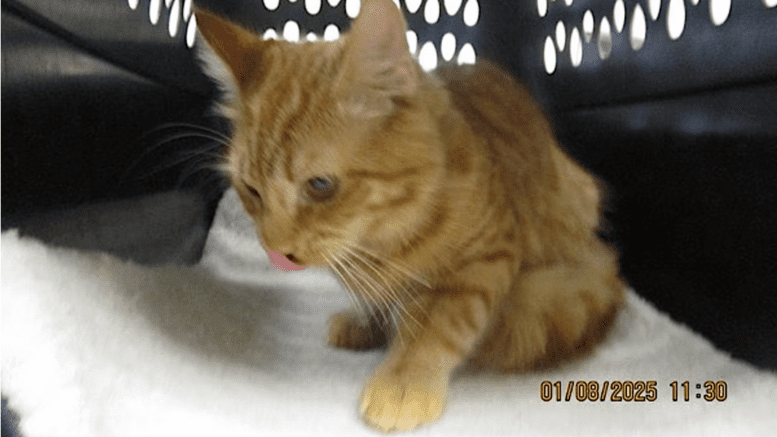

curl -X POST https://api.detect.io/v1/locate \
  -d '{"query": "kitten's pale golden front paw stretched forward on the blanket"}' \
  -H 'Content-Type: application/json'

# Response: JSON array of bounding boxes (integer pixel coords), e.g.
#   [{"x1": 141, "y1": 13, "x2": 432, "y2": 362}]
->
[{"x1": 359, "y1": 371, "x2": 448, "y2": 432}]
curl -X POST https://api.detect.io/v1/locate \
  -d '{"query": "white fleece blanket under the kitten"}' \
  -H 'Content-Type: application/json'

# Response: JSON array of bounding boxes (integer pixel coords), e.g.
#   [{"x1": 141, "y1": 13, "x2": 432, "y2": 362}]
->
[{"x1": 2, "y1": 192, "x2": 777, "y2": 437}]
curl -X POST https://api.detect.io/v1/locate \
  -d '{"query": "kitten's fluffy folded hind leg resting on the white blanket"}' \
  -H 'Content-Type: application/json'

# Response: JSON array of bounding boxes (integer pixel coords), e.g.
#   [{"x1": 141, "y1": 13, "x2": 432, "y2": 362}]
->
[{"x1": 470, "y1": 238, "x2": 625, "y2": 371}]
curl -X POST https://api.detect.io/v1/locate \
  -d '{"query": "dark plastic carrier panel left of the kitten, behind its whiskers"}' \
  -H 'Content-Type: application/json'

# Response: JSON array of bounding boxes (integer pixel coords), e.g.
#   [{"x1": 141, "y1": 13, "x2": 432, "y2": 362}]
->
[{"x1": 2, "y1": 6, "x2": 224, "y2": 223}]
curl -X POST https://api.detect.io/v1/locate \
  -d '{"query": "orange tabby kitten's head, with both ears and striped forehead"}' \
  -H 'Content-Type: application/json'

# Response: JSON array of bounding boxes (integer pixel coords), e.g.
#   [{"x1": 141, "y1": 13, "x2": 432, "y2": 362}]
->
[{"x1": 196, "y1": 0, "x2": 443, "y2": 265}]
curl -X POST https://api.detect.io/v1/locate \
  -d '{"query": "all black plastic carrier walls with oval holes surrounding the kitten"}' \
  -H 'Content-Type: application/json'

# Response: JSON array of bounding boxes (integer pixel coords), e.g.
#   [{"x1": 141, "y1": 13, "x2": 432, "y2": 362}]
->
[{"x1": 2, "y1": 0, "x2": 777, "y2": 435}]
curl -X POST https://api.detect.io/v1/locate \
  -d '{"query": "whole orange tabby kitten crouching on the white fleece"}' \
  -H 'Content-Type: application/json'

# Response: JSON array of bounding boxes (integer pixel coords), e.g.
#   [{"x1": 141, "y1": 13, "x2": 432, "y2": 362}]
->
[{"x1": 196, "y1": 0, "x2": 623, "y2": 431}]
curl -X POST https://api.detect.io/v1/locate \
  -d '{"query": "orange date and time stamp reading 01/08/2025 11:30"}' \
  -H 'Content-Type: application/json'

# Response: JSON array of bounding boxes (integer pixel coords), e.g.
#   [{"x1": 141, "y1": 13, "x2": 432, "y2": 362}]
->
[{"x1": 540, "y1": 380, "x2": 728, "y2": 402}]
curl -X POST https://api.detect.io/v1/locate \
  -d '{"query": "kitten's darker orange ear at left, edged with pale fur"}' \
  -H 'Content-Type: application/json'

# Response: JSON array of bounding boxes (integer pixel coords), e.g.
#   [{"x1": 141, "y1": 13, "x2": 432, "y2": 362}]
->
[{"x1": 194, "y1": 9, "x2": 265, "y2": 89}]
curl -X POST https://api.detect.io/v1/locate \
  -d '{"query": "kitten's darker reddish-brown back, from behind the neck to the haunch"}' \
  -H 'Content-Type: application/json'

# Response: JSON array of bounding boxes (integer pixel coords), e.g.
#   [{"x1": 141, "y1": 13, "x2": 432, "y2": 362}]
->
[{"x1": 436, "y1": 60, "x2": 603, "y2": 264}]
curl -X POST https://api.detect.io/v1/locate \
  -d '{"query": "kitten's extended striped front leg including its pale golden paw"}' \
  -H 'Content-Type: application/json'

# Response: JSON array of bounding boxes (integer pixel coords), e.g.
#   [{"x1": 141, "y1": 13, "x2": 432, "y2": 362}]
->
[{"x1": 359, "y1": 260, "x2": 510, "y2": 432}]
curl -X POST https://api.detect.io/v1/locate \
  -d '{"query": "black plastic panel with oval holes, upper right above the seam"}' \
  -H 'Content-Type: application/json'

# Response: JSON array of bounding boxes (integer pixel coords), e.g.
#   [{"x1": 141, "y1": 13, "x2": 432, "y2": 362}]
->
[{"x1": 483, "y1": 0, "x2": 777, "y2": 110}]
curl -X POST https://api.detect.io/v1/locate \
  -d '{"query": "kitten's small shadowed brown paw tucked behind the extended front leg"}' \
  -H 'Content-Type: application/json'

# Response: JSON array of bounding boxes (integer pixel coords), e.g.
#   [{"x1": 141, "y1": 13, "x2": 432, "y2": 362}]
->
[{"x1": 329, "y1": 311, "x2": 386, "y2": 350}]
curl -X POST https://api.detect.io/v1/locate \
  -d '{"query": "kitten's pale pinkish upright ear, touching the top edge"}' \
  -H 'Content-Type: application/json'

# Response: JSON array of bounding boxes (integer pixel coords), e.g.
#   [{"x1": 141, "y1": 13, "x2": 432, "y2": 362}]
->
[{"x1": 336, "y1": 0, "x2": 420, "y2": 116}]
